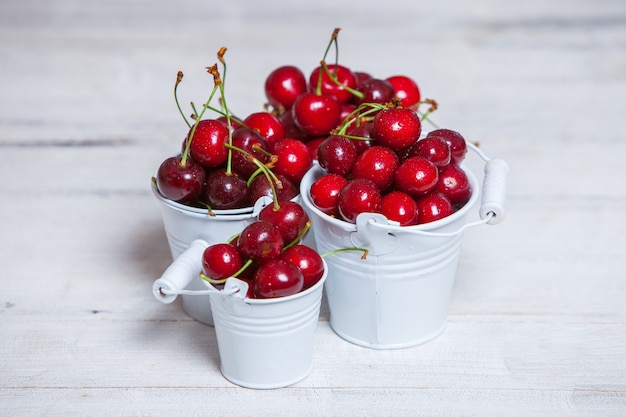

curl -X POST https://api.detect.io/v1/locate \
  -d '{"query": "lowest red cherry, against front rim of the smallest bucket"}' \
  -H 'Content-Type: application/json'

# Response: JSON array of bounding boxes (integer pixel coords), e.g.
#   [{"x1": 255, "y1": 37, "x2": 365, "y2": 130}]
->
[{"x1": 252, "y1": 259, "x2": 304, "y2": 298}]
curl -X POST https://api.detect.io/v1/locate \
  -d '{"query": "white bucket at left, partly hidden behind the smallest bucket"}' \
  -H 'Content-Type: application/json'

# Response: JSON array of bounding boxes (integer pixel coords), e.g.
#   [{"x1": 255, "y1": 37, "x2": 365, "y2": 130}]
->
[{"x1": 152, "y1": 182, "x2": 271, "y2": 325}]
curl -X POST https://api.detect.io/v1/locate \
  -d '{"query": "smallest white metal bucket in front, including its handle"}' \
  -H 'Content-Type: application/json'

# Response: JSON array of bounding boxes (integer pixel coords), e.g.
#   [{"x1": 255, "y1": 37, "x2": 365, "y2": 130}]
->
[{"x1": 152, "y1": 240, "x2": 328, "y2": 389}]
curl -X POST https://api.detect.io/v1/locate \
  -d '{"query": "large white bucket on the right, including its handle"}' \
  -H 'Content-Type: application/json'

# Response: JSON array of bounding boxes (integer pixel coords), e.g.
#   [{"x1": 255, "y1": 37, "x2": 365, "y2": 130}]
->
[{"x1": 300, "y1": 145, "x2": 508, "y2": 349}]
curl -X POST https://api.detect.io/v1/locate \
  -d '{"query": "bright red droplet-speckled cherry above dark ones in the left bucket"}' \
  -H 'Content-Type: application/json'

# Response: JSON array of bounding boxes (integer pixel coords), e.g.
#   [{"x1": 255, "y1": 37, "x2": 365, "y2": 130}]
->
[{"x1": 188, "y1": 119, "x2": 229, "y2": 168}]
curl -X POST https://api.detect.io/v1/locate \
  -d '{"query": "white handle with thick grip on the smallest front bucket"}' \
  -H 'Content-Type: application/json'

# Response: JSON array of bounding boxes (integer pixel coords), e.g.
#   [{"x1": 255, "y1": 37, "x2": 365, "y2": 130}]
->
[{"x1": 152, "y1": 239, "x2": 248, "y2": 304}]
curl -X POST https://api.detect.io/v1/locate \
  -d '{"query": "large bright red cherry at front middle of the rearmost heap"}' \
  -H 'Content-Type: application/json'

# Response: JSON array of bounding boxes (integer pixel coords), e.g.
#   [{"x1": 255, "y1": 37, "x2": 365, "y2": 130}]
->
[{"x1": 291, "y1": 93, "x2": 341, "y2": 136}]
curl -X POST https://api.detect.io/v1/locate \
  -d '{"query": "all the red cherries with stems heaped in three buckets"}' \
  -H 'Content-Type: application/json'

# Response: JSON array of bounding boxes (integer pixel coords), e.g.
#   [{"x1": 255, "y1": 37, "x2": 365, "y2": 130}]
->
[{"x1": 154, "y1": 30, "x2": 472, "y2": 298}]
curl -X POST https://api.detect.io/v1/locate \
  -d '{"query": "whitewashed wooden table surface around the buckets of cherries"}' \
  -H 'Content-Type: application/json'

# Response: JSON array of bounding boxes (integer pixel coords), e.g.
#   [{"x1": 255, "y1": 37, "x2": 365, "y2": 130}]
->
[{"x1": 0, "y1": 0, "x2": 626, "y2": 417}]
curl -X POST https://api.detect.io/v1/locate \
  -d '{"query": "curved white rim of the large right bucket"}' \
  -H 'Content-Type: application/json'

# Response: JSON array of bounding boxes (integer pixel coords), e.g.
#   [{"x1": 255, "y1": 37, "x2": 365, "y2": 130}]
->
[{"x1": 300, "y1": 162, "x2": 480, "y2": 232}]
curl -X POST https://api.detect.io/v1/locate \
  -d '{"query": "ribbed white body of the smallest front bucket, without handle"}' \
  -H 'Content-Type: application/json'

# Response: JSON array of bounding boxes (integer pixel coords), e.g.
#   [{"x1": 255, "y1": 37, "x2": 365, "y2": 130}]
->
[{"x1": 206, "y1": 268, "x2": 327, "y2": 389}]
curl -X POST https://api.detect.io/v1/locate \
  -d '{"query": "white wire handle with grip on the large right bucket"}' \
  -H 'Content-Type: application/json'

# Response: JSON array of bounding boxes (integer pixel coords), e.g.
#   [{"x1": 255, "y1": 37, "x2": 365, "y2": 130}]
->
[{"x1": 368, "y1": 142, "x2": 509, "y2": 237}]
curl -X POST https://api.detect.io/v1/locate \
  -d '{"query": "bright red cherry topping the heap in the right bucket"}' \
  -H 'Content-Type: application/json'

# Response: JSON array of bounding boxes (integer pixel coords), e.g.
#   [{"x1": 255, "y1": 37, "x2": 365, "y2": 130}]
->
[{"x1": 372, "y1": 108, "x2": 422, "y2": 151}]
